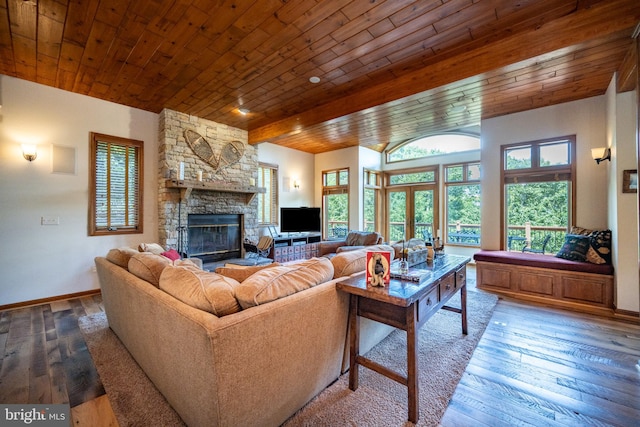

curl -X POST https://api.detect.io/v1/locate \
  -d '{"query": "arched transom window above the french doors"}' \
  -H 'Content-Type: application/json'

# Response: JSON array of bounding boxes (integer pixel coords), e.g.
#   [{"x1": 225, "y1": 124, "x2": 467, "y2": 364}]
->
[{"x1": 387, "y1": 133, "x2": 480, "y2": 163}]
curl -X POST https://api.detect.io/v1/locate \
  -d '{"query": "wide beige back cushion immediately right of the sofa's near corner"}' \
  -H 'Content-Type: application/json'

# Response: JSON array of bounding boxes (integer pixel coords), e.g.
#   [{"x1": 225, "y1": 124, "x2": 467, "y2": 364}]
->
[{"x1": 236, "y1": 258, "x2": 333, "y2": 309}]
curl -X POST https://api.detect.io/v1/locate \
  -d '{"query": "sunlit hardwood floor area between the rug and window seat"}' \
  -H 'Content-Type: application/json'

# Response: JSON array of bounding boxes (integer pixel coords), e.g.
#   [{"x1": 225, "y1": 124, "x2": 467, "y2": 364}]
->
[{"x1": 442, "y1": 300, "x2": 640, "y2": 427}]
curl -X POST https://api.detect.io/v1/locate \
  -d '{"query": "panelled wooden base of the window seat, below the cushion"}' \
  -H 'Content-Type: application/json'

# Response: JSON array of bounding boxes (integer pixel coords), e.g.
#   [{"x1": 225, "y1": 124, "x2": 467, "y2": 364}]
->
[{"x1": 476, "y1": 261, "x2": 614, "y2": 316}]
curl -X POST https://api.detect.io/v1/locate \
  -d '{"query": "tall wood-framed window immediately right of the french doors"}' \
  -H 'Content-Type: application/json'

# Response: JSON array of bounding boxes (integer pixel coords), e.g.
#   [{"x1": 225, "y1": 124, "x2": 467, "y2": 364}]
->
[{"x1": 438, "y1": 162, "x2": 481, "y2": 246}]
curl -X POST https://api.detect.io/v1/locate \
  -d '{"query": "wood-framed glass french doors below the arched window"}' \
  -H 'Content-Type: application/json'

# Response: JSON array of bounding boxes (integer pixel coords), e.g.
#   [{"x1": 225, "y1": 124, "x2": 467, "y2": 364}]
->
[{"x1": 385, "y1": 184, "x2": 438, "y2": 242}]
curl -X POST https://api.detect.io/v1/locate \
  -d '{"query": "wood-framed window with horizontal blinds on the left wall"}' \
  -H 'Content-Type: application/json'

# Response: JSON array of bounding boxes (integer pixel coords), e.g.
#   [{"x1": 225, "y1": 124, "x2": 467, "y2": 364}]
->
[{"x1": 89, "y1": 132, "x2": 143, "y2": 236}]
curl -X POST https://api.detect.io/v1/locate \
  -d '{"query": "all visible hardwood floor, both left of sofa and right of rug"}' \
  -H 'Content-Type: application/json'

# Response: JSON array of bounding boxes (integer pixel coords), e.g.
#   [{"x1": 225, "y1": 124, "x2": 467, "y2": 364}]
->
[{"x1": 0, "y1": 268, "x2": 640, "y2": 427}]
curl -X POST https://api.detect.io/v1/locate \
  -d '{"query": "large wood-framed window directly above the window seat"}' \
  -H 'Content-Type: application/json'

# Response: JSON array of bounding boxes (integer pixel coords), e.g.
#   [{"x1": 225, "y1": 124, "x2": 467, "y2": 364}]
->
[{"x1": 502, "y1": 136, "x2": 576, "y2": 253}]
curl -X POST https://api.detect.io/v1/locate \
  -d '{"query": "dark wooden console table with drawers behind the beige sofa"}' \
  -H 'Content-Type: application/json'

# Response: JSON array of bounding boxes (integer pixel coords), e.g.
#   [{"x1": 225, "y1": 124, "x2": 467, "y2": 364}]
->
[{"x1": 336, "y1": 255, "x2": 470, "y2": 423}]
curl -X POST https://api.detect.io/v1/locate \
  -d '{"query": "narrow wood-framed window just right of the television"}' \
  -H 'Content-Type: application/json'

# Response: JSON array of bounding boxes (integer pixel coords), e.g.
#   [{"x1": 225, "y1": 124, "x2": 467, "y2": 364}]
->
[{"x1": 322, "y1": 169, "x2": 349, "y2": 239}]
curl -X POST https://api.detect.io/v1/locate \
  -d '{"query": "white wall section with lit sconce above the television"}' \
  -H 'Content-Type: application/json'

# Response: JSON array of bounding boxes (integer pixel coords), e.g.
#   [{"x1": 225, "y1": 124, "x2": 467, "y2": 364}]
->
[{"x1": 257, "y1": 142, "x2": 314, "y2": 235}]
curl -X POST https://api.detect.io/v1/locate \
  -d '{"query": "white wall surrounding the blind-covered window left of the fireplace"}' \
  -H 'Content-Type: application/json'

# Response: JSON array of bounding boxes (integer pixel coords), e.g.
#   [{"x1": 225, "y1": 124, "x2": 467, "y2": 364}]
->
[{"x1": 0, "y1": 76, "x2": 158, "y2": 306}]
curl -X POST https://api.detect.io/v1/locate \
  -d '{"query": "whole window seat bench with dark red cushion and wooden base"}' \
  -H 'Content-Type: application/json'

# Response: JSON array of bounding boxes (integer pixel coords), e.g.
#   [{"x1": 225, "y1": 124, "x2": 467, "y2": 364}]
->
[{"x1": 473, "y1": 250, "x2": 614, "y2": 316}]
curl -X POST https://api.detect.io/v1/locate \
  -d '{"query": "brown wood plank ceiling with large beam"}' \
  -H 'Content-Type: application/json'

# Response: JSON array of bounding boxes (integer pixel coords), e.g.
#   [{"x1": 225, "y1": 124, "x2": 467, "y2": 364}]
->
[{"x1": 0, "y1": 0, "x2": 640, "y2": 153}]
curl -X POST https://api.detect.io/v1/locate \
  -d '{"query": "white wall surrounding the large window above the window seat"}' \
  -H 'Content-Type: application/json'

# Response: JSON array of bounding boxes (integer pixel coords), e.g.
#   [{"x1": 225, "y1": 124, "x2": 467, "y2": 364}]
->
[{"x1": 481, "y1": 96, "x2": 608, "y2": 249}]
